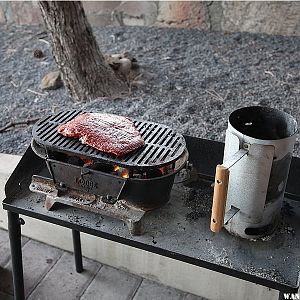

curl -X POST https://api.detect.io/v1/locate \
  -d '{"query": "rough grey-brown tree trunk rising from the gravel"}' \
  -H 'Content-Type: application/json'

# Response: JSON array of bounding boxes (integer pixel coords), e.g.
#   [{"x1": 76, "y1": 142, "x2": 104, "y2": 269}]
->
[{"x1": 39, "y1": 1, "x2": 128, "y2": 101}]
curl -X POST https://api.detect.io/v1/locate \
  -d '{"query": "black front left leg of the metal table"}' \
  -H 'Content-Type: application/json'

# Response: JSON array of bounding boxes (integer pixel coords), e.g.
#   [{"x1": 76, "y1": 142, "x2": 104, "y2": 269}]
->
[{"x1": 7, "y1": 211, "x2": 25, "y2": 300}]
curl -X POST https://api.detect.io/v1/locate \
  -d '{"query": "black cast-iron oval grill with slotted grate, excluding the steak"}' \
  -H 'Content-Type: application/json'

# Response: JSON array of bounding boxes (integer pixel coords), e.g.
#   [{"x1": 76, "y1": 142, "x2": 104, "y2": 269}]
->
[{"x1": 32, "y1": 111, "x2": 188, "y2": 211}]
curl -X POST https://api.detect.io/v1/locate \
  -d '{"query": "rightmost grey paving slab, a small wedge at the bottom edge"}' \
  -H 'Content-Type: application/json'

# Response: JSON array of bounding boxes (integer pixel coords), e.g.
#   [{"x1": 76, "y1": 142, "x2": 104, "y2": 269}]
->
[{"x1": 133, "y1": 279, "x2": 184, "y2": 300}]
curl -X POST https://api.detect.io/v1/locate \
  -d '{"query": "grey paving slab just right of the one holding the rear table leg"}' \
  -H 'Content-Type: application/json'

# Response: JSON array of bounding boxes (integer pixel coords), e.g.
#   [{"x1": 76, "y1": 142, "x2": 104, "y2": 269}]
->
[{"x1": 80, "y1": 266, "x2": 142, "y2": 300}]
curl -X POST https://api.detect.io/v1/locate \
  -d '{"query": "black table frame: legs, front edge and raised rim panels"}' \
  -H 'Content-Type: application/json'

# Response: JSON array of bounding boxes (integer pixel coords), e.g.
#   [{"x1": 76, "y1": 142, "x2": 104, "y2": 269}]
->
[{"x1": 3, "y1": 136, "x2": 300, "y2": 300}]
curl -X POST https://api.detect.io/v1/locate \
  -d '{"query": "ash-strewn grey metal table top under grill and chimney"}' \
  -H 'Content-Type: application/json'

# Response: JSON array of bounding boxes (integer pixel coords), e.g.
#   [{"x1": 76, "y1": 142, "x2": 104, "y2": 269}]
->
[{"x1": 3, "y1": 137, "x2": 300, "y2": 292}]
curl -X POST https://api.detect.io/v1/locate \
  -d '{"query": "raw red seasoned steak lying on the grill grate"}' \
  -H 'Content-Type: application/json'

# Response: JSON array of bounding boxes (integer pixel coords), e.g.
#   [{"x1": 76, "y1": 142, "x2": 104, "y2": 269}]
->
[{"x1": 57, "y1": 113, "x2": 145, "y2": 156}]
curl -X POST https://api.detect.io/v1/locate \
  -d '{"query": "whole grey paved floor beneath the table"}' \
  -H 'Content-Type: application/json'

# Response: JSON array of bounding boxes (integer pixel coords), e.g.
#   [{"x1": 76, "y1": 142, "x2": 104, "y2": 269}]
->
[{"x1": 0, "y1": 230, "x2": 206, "y2": 300}]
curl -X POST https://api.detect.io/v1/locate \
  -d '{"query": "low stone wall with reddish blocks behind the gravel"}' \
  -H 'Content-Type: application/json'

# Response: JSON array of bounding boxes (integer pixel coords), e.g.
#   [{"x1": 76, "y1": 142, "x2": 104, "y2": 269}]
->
[{"x1": 0, "y1": 1, "x2": 300, "y2": 36}]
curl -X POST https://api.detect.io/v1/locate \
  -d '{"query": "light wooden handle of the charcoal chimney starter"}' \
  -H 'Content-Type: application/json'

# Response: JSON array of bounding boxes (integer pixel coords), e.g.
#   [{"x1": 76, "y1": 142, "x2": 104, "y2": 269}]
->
[{"x1": 210, "y1": 165, "x2": 229, "y2": 232}]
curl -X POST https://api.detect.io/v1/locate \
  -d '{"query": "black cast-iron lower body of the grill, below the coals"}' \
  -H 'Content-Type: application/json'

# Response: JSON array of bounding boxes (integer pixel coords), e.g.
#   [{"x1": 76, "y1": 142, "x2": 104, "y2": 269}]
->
[{"x1": 48, "y1": 160, "x2": 176, "y2": 211}]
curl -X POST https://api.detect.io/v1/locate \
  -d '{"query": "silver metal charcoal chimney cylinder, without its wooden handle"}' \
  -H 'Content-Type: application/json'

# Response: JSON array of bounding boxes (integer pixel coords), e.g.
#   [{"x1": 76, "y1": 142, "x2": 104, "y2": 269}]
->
[{"x1": 223, "y1": 106, "x2": 297, "y2": 239}]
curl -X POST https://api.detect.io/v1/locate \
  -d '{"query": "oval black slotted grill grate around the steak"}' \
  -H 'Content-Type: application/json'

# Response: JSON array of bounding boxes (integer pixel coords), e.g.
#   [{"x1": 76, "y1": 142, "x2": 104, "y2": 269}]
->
[{"x1": 33, "y1": 110, "x2": 186, "y2": 169}]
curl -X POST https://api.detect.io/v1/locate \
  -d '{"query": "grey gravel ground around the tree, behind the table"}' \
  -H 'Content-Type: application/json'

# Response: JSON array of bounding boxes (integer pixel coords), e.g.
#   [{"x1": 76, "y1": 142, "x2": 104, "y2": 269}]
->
[{"x1": 0, "y1": 26, "x2": 300, "y2": 156}]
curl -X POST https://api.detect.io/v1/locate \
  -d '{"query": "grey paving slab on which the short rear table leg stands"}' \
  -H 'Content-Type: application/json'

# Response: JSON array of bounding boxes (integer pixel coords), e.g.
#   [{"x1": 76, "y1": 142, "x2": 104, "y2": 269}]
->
[{"x1": 28, "y1": 252, "x2": 101, "y2": 300}]
